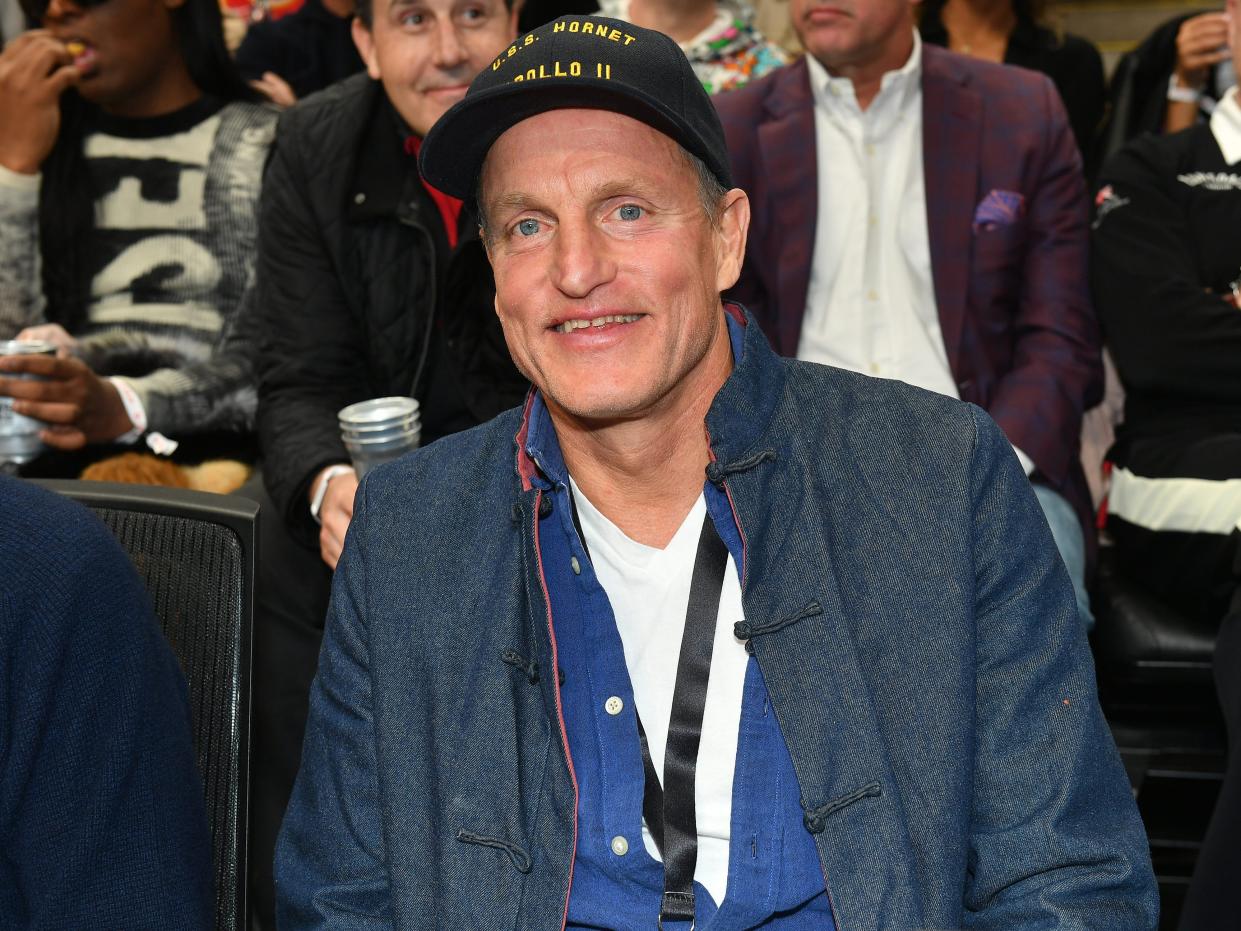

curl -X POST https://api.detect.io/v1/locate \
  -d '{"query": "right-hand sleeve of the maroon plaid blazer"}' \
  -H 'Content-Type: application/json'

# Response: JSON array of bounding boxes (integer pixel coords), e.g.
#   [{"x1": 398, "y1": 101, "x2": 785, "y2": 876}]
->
[{"x1": 974, "y1": 79, "x2": 1103, "y2": 487}]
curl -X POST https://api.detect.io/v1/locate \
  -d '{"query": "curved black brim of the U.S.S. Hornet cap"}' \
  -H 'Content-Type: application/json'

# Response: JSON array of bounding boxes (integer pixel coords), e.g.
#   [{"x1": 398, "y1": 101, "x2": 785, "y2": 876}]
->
[{"x1": 419, "y1": 77, "x2": 709, "y2": 200}]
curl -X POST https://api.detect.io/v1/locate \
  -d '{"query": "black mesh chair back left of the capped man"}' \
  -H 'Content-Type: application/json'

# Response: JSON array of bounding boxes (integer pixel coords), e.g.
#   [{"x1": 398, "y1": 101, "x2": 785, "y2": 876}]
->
[{"x1": 40, "y1": 480, "x2": 258, "y2": 931}]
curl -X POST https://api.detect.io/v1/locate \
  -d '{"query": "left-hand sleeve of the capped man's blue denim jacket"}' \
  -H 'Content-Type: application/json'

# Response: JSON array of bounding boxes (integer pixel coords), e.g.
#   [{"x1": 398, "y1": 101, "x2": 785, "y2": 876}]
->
[{"x1": 276, "y1": 482, "x2": 393, "y2": 931}]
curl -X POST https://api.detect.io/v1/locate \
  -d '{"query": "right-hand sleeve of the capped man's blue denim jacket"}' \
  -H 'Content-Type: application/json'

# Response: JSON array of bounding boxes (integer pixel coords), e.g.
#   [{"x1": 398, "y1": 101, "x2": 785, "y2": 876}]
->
[{"x1": 963, "y1": 407, "x2": 1159, "y2": 931}]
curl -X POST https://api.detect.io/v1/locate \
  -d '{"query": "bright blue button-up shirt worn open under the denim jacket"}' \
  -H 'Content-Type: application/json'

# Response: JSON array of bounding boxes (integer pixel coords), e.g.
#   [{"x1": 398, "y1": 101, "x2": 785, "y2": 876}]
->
[{"x1": 526, "y1": 318, "x2": 835, "y2": 931}]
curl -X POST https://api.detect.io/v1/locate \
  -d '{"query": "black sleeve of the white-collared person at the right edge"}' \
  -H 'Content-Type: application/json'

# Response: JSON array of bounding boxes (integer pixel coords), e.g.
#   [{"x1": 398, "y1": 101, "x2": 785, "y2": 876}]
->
[{"x1": 1091, "y1": 130, "x2": 1241, "y2": 403}]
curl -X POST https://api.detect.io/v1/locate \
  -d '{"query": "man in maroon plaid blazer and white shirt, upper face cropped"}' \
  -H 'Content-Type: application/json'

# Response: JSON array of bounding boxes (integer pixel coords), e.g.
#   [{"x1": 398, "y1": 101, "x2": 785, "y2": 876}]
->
[{"x1": 716, "y1": 0, "x2": 1102, "y2": 624}]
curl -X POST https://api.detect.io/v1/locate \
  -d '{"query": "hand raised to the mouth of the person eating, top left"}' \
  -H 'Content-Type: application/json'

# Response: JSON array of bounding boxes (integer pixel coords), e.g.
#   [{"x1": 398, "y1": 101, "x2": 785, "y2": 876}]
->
[{"x1": 0, "y1": 29, "x2": 79, "y2": 175}]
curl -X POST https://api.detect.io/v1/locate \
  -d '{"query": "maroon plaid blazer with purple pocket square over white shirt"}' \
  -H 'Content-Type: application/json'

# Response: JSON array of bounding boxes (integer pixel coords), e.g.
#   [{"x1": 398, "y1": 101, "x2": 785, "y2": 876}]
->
[{"x1": 715, "y1": 46, "x2": 1103, "y2": 540}]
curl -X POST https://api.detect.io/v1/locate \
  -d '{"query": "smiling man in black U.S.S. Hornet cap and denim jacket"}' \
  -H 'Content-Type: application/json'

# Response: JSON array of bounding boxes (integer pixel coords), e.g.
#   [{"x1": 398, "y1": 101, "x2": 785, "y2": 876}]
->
[{"x1": 277, "y1": 17, "x2": 1157, "y2": 931}]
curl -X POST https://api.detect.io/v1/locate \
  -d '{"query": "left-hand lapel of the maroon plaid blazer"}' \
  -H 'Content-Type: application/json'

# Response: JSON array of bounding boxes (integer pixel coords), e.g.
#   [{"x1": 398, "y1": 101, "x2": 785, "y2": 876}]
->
[{"x1": 758, "y1": 58, "x2": 819, "y2": 356}]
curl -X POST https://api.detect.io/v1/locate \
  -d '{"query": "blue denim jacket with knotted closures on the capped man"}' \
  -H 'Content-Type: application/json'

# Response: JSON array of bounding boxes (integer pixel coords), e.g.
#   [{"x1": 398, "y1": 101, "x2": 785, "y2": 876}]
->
[{"x1": 276, "y1": 310, "x2": 1158, "y2": 931}]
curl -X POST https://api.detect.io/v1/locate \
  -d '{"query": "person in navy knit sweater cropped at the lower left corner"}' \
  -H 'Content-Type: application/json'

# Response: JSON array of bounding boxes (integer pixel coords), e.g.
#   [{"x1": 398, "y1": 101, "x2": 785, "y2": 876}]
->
[{"x1": 0, "y1": 475, "x2": 215, "y2": 931}]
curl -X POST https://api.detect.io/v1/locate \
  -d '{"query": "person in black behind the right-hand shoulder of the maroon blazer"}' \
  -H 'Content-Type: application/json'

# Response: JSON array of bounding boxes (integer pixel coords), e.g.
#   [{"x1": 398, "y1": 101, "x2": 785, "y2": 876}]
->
[{"x1": 920, "y1": 0, "x2": 1107, "y2": 170}]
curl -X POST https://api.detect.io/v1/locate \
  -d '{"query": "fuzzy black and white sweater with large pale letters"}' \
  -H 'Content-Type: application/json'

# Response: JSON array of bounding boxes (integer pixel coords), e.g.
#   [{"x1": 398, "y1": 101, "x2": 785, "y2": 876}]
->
[{"x1": 0, "y1": 98, "x2": 277, "y2": 437}]
